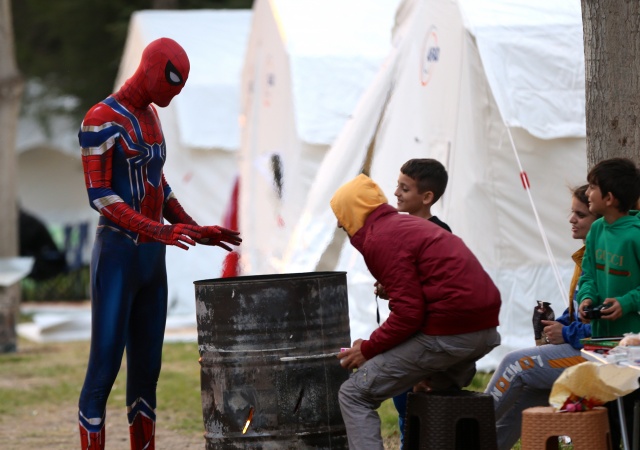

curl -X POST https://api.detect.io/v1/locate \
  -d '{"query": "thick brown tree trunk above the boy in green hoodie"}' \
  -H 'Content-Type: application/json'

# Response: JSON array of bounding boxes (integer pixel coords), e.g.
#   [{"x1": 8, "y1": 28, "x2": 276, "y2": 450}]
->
[{"x1": 582, "y1": 0, "x2": 640, "y2": 167}]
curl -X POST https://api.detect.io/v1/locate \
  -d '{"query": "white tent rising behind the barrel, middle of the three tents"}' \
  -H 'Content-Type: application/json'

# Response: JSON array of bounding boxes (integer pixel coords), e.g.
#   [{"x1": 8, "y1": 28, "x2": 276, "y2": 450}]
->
[{"x1": 239, "y1": 0, "x2": 398, "y2": 274}]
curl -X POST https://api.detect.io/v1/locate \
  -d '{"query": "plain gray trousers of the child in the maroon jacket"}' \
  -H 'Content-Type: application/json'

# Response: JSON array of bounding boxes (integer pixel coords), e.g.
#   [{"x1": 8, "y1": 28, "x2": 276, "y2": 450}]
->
[{"x1": 338, "y1": 328, "x2": 500, "y2": 450}]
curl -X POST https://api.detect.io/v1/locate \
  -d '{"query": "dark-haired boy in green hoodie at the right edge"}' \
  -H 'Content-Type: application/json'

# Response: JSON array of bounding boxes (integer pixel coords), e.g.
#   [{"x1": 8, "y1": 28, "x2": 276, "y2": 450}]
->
[{"x1": 578, "y1": 158, "x2": 640, "y2": 337}]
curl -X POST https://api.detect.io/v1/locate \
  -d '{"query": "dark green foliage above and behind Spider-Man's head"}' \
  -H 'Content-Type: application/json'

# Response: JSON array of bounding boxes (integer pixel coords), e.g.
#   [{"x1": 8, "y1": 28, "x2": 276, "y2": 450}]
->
[{"x1": 11, "y1": 0, "x2": 253, "y2": 117}]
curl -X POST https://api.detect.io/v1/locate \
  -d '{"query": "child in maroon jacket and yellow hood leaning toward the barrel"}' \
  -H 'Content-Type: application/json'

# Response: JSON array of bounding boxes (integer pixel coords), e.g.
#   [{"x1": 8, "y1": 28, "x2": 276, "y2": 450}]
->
[{"x1": 331, "y1": 174, "x2": 501, "y2": 450}]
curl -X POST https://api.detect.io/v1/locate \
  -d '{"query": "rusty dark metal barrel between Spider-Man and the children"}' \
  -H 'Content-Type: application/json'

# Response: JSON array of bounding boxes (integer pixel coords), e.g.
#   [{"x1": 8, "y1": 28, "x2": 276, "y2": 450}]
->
[{"x1": 194, "y1": 272, "x2": 350, "y2": 450}]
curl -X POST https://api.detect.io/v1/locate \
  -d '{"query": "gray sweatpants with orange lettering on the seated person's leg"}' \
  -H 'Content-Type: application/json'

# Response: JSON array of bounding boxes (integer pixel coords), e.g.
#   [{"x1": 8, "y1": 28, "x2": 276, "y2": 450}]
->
[{"x1": 485, "y1": 344, "x2": 585, "y2": 450}]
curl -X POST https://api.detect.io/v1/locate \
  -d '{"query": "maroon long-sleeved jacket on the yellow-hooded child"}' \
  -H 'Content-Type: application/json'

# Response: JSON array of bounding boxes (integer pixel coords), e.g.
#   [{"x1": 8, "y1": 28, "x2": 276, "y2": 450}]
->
[{"x1": 351, "y1": 204, "x2": 501, "y2": 359}]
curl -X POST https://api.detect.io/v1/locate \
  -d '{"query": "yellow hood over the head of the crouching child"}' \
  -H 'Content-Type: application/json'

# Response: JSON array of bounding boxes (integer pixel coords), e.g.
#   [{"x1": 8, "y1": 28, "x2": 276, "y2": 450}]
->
[{"x1": 330, "y1": 174, "x2": 387, "y2": 236}]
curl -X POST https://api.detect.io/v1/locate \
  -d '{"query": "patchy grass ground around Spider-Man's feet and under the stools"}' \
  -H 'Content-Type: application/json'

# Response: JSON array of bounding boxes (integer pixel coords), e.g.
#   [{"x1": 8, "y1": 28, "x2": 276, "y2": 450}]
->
[{"x1": 0, "y1": 341, "x2": 496, "y2": 450}]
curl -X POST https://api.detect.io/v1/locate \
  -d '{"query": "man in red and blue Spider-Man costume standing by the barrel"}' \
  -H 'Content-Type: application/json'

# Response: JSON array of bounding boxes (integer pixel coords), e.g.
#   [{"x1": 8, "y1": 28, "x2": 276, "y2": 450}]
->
[{"x1": 78, "y1": 38, "x2": 241, "y2": 450}]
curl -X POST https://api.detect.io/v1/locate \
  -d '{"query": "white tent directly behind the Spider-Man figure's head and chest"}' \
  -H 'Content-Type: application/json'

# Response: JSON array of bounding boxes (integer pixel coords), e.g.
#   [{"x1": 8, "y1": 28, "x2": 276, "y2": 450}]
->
[{"x1": 115, "y1": 10, "x2": 252, "y2": 318}]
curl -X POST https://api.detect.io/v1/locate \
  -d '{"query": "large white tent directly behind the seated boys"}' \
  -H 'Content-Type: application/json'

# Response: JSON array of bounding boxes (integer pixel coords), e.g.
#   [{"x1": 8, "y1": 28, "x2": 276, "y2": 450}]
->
[{"x1": 278, "y1": 0, "x2": 586, "y2": 370}]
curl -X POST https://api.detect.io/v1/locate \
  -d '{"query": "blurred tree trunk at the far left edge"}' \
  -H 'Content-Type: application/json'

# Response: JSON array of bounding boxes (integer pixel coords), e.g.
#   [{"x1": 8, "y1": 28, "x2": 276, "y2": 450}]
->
[{"x1": 0, "y1": 0, "x2": 22, "y2": 353}]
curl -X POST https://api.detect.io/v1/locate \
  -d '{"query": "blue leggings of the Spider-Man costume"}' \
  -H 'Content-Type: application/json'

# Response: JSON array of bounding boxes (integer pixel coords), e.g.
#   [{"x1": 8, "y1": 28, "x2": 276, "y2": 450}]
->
[{"x1": 79, "y1": 227, "x2": 167, "y2": 432}]
